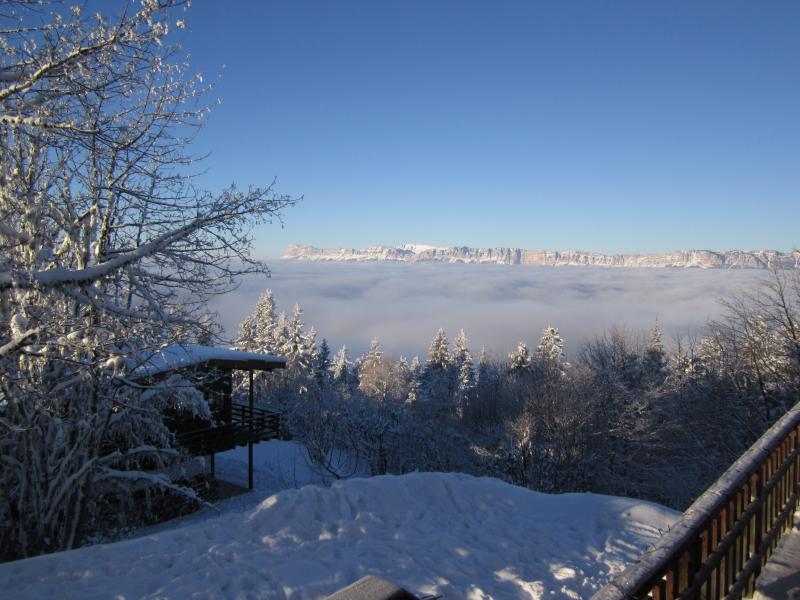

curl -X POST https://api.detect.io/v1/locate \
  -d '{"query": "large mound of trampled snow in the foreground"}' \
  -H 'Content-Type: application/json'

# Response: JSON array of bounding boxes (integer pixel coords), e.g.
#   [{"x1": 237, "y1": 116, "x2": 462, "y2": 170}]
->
[{"x1": 0, "y1": 473, "x2": 678, "y2": 600}]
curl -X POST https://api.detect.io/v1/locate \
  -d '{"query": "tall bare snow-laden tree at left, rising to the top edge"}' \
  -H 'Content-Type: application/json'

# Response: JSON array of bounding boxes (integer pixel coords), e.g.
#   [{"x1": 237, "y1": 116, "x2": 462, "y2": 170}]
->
[{"x1": 0, "y1": 0, "x2": 292, "y2": 558}]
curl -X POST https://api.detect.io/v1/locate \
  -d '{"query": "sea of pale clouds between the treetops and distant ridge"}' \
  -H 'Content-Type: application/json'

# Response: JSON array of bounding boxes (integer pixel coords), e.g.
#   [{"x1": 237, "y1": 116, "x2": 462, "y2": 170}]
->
[{"x1": 212, "y1": 261, "x2": 768, "y2": 358}]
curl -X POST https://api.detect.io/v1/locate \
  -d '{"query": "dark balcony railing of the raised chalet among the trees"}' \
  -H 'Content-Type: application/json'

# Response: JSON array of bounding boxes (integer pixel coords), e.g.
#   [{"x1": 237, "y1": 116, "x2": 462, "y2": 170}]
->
[{"x1": 176, "y1": 403, "x2": 281, "y2": 456}]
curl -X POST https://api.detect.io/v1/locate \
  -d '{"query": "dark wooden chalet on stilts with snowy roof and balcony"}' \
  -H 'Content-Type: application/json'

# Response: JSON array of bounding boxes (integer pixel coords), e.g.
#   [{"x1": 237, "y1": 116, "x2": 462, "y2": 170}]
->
[{"x1": 132, "y1": 344, "x2": 286, "y2": 489}]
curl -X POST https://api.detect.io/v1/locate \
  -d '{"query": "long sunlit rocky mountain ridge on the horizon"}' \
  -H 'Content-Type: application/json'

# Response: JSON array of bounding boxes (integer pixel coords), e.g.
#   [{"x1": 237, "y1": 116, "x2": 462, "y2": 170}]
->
[{"x1": 281, "y1": 244, "x2": 800, "y2": 269}]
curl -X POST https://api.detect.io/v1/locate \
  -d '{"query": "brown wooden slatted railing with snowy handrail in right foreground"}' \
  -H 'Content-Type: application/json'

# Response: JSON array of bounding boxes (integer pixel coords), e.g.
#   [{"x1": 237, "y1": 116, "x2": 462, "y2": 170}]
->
[{"x1": 592, "y1": 404, "x2": 800, "y2": 600}]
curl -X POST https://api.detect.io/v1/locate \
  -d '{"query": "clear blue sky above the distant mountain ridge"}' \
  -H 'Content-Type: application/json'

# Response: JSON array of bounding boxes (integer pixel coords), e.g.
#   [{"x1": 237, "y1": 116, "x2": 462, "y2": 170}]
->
[{"x1": 183, "y1": 0, "x2": 800, "y2": 258}]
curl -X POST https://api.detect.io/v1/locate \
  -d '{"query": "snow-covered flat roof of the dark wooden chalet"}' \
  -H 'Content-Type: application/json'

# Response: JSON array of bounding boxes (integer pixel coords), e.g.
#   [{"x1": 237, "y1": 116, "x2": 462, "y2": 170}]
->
[{"x1": 131, "y1": 344, "x2": 286, "y2": 378}]
